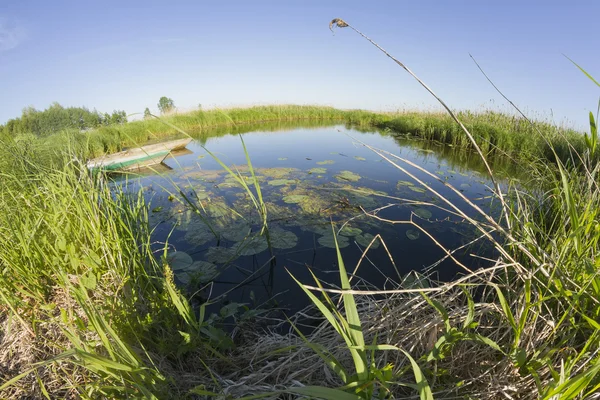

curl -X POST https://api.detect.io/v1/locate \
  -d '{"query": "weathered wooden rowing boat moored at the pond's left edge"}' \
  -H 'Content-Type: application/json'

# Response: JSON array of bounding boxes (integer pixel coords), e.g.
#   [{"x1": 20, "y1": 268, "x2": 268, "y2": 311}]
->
[{"x1": 87, "y1": 139, "x2": 192, "y2": 171}]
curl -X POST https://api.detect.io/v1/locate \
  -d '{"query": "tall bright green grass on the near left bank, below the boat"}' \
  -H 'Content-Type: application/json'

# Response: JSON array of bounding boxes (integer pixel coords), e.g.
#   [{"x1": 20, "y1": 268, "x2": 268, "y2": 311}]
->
[{"x1": 0, "y1": 149, "x2": 231, "y2": 398}]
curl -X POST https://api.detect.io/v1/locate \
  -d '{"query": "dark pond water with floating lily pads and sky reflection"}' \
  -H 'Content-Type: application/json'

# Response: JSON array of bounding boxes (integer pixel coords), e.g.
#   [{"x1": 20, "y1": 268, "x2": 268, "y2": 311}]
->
[{"x1": 112, "y1": 125, "x2": 510, "y2": 310}]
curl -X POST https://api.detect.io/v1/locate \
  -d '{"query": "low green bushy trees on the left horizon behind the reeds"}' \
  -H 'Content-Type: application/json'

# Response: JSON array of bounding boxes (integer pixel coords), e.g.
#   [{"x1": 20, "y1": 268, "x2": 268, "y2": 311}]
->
[{"x1": 0, "y1": 102, "x2": 127, "y2": 136}]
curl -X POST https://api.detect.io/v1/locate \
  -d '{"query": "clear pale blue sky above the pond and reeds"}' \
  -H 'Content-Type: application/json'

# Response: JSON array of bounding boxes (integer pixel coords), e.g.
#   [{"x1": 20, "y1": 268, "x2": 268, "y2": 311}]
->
[{"x1": 0, "y1": 0, "x2": 600, "y2": 129}]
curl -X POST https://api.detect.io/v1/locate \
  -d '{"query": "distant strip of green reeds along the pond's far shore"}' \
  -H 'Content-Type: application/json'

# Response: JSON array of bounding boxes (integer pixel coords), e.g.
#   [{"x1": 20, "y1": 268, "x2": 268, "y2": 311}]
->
[{"x1": 2, "y1": 105, "x2": 585, "y2": 169}]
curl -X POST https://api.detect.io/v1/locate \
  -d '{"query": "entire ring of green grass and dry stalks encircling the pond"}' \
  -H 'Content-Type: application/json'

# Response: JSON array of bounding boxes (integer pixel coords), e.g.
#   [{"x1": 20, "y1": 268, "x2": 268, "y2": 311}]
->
[{"x1": 0, "y1": 106, "x2": 600, "y2": 399}]
